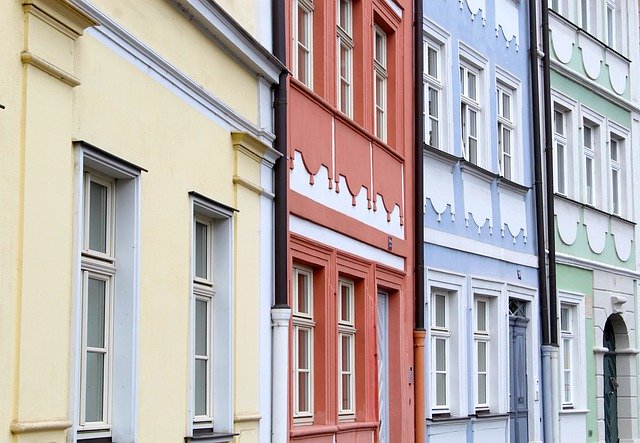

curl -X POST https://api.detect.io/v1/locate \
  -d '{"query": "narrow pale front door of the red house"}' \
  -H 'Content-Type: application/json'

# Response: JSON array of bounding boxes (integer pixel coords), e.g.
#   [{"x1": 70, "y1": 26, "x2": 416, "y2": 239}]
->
[{"x1": 377, "y1": 292, "x2": 389, "y2": 443}]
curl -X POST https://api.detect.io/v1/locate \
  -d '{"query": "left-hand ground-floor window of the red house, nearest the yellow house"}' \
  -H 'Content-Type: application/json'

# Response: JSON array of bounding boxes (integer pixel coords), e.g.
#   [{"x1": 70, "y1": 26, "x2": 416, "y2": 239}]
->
[{"x1": 292, "y1": 266, "x2": 315, "y2": 422}]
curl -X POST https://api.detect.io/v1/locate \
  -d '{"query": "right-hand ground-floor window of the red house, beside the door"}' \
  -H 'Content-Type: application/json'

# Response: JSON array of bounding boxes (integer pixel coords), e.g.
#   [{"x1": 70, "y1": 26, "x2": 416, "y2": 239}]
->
[{"x1": 338, "y1": 279, "x2": 356, "y2": 419}]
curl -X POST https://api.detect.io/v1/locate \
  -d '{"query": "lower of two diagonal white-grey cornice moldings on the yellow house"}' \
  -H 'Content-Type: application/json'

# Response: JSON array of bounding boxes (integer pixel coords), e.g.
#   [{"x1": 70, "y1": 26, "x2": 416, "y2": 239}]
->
[{"x1": 70, "y1": 0, "x2": 275, "y2": 145}]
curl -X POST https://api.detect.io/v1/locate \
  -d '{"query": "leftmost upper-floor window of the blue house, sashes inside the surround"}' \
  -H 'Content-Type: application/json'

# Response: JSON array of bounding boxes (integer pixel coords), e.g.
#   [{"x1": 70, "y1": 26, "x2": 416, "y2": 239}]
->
[{"x1": 424, "y1": 40, "x2": 444, "y2": 149}]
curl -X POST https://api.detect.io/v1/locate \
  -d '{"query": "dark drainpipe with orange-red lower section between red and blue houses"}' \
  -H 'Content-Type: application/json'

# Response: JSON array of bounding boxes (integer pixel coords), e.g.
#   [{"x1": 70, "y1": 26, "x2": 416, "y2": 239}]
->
[{"x1": 413, "y1": 0, "x2": 426, "y2": 443}]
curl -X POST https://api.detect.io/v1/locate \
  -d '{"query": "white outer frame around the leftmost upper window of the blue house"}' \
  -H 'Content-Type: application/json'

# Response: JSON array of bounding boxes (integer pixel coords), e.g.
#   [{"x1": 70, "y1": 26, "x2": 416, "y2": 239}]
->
[{"x1": 422, "y1": 18, "x2": 453, "y2": 153}]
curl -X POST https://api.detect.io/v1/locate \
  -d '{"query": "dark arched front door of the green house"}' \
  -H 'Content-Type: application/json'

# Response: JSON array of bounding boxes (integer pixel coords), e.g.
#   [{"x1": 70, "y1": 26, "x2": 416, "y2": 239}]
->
[{"x1": 602, "y1": 320, "x2": 620, "y2": 443}]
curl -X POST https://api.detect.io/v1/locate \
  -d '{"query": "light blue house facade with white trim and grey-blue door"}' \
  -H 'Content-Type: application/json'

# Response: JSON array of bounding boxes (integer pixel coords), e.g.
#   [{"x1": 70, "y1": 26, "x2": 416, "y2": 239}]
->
[{"x1": 423, "y1": 0, "x2": 543, "y2": 443}]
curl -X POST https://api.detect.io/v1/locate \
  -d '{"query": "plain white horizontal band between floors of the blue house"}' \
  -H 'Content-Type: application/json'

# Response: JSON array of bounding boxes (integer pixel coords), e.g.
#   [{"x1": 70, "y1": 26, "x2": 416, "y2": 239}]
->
[{"x1": 424, "y1": 228, "x2": 538, "y2": 269}]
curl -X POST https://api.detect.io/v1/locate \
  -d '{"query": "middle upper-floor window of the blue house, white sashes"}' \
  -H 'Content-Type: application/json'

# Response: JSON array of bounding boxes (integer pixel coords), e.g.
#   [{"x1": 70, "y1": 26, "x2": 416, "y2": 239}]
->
[{"x1": 460, "y1": 61, "x2": 482, "y2": 165}]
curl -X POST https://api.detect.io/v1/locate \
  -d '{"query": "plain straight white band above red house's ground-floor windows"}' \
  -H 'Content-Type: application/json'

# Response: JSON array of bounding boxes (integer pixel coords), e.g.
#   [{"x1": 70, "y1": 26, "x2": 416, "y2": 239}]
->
[{"x1": 289, "y1": 215, "x2": 405, "y2": 271}]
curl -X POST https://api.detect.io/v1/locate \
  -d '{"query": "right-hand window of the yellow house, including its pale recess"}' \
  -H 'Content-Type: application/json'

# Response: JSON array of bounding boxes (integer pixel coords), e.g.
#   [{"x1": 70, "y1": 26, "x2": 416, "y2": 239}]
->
[{"x1": 187, "y1": 196, "x2": 233, "y2": 438}]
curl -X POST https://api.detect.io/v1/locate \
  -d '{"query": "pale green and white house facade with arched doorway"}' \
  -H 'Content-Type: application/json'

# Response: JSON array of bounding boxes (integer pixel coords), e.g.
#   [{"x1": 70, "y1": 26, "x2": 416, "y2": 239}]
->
[{"x1": 547, "y1": 0, "x2": 640, "y2": 442}]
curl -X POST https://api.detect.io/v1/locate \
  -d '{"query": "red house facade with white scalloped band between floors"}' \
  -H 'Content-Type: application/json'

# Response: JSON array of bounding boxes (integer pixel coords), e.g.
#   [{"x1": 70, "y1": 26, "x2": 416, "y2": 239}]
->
[{"x1": 282, "y1": 0, "x2": 413, "y2": 442}]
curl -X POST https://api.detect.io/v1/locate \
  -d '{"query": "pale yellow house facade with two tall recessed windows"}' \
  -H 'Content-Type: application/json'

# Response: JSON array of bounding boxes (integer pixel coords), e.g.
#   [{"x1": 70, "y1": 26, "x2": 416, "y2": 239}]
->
[{"x1": 0, "y1": 0, "x2": 283, "y2": 443}]
